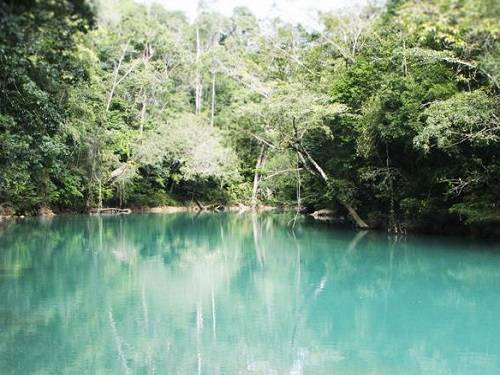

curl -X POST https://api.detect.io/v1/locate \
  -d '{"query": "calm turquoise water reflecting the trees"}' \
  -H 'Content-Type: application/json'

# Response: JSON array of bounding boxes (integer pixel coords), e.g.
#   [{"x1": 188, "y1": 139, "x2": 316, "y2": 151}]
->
[{"x1": 0, "y1": 214, "x2": 500, "y2": 375}]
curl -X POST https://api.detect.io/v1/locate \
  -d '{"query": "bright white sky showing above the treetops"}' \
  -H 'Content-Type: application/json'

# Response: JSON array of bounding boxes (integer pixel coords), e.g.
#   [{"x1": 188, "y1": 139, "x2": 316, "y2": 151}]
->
[{"x1": 139, "y1": 0, "x2": 368, "y2": 25}]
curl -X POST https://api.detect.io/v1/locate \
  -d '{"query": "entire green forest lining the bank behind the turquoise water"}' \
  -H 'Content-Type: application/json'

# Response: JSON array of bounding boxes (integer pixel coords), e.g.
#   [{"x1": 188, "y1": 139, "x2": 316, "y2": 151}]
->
[{"x1": 0, "y1": 0, "x2": 500, "y2": 235}]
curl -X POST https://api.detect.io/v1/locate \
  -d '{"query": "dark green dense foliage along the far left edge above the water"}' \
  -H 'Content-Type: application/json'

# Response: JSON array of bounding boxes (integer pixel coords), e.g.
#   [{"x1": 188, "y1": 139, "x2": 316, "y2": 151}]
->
[{"x1": 0, "y1": 0, "x2": 92, "y2": 212}]
